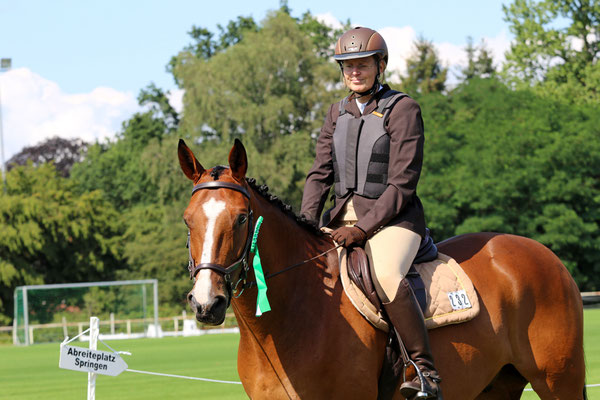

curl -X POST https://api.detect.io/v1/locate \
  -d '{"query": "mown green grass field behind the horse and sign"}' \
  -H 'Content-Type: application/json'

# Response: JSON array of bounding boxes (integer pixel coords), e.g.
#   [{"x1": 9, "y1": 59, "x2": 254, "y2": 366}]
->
[{"x1": 0, "y1": 309, "x2": 600, "y2": 400}]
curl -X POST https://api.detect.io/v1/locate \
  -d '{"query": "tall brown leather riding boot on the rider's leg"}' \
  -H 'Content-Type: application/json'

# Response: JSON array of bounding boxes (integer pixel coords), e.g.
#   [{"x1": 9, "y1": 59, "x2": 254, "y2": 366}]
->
[{"x1": 383, "y1": 279, "x2": 442, "y2": 400}]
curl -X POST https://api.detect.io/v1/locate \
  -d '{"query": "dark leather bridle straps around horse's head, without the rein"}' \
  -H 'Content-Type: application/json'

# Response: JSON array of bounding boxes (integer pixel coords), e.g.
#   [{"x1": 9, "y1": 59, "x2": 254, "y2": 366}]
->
[{"x1": 187, "y1": 181, "x2": 254, "y2": 294}]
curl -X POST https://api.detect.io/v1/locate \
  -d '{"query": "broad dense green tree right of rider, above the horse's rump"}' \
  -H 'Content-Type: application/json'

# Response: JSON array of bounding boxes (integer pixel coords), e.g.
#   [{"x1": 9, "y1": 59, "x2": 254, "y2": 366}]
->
[{"x1": 420, "y1": 78, "x2": 600, "y2": 289}]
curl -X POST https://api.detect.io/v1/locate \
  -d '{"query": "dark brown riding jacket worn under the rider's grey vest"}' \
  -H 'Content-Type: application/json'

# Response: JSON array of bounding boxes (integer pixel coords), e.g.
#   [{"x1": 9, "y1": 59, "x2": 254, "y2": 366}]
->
[{"x1": 300, "y1": 85, "x2": 425, "y2": 238}]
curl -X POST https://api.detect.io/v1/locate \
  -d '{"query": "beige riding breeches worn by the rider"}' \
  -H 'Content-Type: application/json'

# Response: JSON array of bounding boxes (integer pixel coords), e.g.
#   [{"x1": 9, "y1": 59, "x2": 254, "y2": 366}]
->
[{"x1": 331, "y1": 199, "x2": 421, "y2": 303}]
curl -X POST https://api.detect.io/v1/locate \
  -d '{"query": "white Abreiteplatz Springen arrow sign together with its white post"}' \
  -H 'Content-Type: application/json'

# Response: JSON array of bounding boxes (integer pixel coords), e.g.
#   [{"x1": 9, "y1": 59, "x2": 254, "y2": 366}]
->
[{"x1": 58, "y1": 317, "x2": 127, "y2": 400}]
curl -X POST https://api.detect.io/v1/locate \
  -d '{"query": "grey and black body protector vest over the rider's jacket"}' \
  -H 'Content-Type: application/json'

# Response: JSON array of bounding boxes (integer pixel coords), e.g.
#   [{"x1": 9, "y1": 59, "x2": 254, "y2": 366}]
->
[{"x1": 332, "y1": 90, "x2": 407, "y2": 199}]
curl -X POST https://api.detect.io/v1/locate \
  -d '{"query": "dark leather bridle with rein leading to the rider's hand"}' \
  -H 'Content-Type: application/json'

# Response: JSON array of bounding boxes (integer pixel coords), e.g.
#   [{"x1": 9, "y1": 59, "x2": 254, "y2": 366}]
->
[{"x1": 186, "y1": 181, "x2": 341, "y2": 298}]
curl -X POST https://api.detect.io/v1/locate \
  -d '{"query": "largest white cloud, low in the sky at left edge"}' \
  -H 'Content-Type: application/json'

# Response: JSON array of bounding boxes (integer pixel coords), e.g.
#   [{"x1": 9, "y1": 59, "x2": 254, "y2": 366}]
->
[{"x1": 0, "y1": 68, "x2": 140, "y2": 160}]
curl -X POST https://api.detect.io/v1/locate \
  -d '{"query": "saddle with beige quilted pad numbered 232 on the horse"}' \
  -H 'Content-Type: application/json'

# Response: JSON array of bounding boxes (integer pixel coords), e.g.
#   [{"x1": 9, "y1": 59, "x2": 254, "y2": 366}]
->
[{"x1": 340, "y1": 229, "x2": 479, "y2": 400}]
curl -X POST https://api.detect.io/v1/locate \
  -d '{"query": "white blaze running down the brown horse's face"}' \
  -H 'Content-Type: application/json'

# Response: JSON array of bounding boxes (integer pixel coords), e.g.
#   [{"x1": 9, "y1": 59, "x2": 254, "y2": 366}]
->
[{"x1": 193, "y1": 199, "x2": 225, "y2": 304}]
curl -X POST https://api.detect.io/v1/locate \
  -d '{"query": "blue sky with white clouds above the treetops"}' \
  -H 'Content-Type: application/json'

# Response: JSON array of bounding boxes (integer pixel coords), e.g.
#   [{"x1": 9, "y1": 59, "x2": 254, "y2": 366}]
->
[{"x1": 0, "y1": 0, "x2": 512, "y2": 160}]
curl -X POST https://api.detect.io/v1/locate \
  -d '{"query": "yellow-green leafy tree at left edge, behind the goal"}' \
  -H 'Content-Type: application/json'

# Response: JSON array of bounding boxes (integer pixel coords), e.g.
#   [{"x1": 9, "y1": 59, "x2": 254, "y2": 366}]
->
[{"x1": 0, "y1": 163, "x2": 122, "y2": 325}]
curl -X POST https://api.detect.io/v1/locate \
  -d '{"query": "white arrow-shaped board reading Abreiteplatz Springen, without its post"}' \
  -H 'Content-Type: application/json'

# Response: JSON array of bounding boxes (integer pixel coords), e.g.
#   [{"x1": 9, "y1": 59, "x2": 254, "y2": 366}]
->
[{"x1": 58, "y1": 345, "x2": 127, "y2": 376}]
